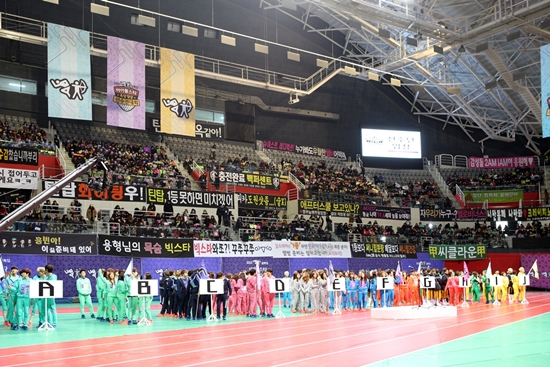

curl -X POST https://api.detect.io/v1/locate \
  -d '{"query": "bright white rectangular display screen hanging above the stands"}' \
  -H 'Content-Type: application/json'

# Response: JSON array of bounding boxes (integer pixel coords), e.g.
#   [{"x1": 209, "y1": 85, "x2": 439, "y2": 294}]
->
[{"x1": 361, "y1": 129, "x2": 422, "y2": 159}]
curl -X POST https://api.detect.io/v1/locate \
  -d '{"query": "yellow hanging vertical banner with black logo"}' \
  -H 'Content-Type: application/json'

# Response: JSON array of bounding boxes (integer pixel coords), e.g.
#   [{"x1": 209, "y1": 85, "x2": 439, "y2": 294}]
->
[{"x1": 160, "y1": 48, "x2": 195, "y2": 137}]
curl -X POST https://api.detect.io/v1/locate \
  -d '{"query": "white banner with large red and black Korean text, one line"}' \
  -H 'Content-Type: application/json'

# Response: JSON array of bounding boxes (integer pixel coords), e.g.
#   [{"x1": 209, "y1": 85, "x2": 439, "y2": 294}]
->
[{"x1": 193, "y1": 241, "x2": 273, "y2": 257}]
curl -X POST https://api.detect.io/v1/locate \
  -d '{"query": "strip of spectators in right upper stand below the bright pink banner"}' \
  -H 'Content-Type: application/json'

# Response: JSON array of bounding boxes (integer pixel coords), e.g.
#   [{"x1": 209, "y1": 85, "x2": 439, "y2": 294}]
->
[{"x1": 445, "y1": 167, "x2": 544, "y2": 195}]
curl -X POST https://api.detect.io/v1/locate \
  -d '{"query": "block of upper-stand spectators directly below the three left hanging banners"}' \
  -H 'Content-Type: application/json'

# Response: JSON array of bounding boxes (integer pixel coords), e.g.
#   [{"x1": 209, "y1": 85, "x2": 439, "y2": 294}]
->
[{"x1": 65, "y1": 139, "x2": 191, "y2": 189}]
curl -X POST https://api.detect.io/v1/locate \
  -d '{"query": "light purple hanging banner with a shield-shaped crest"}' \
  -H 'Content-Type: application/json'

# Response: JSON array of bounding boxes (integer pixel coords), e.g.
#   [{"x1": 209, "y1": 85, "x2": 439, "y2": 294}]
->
[{"x1": 107, "y1": 37, "x2": 145, "y2": 130}]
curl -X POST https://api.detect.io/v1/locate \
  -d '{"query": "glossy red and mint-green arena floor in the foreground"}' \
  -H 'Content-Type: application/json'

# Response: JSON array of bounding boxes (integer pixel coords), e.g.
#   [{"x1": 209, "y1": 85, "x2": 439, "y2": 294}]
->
[{"x1": 0, "y1": 292, "x2": 550, "y2": 367}]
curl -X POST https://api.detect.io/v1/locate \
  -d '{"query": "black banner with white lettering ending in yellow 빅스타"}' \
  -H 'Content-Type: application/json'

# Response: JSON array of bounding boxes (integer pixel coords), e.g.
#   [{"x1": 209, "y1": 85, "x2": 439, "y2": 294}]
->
[{"x1": 98, "y1": 235, "x2": 194, "y2": 258}]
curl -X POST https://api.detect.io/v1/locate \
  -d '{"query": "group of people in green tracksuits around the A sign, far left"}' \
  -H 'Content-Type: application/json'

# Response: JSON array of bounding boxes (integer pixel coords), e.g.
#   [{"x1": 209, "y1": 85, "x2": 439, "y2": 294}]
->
[{"x1": 0, "y1": 264, "x2": 57, "y2": 331}]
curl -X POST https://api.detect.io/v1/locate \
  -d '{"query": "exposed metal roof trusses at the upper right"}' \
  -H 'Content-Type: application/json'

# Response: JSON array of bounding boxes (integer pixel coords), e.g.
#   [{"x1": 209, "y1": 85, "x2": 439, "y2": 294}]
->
[{"x1": 259, "y1": 0, "x2": 550, "y2": 154}]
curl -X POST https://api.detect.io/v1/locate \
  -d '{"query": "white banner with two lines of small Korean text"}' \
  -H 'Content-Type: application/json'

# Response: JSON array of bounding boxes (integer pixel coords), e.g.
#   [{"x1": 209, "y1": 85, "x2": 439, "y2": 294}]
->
[{"x1": 270, "y1": 241, "x2": 351, "y2": 258}]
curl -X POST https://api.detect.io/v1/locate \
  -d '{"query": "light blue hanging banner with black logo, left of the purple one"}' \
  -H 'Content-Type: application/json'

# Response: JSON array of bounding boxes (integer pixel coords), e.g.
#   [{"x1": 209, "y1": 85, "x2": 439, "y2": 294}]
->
[{"x1": 48, "y1": 23, "x2": 92, "y2": 120}]
